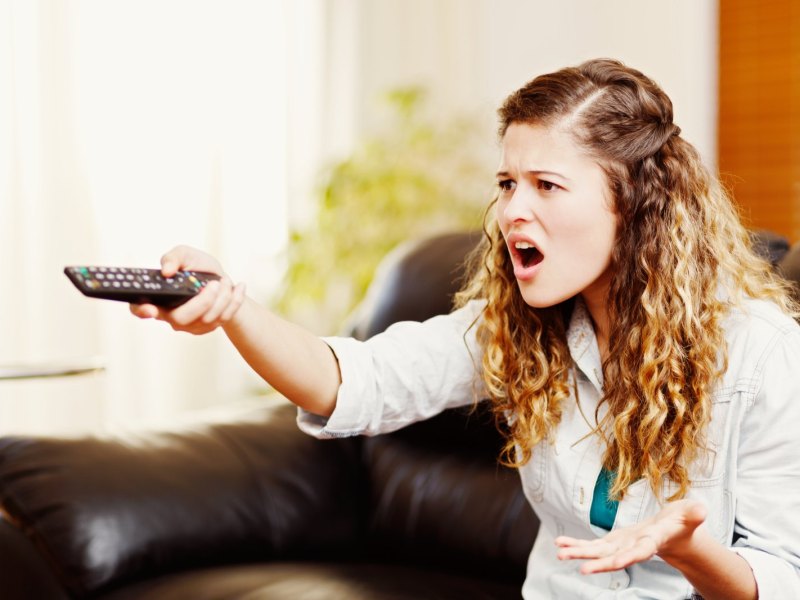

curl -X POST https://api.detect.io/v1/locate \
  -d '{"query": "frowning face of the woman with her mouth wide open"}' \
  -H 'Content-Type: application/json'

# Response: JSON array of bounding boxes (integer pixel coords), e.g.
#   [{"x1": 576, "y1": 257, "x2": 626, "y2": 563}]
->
[{"x1": 496, "y1": 123, "x2": 617, "y2": 310}]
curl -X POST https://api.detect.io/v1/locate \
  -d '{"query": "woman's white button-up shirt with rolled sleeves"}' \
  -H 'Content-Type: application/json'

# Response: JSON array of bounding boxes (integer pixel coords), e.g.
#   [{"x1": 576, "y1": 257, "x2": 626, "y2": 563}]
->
[{"x1": 298, "y1": 300, "x2": 800, "y2": 600}]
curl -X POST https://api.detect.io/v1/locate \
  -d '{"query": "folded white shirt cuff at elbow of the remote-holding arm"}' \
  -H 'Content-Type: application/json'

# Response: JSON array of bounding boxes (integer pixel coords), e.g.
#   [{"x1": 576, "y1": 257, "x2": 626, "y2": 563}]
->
[{"x1": 297, "y1": 337, "x2": 371, "y2": 439}]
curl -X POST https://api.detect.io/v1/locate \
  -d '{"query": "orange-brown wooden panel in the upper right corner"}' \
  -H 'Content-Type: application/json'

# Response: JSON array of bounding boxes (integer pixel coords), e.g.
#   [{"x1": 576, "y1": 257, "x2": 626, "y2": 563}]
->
[{"x1": 718, "y1": 0, "x2": 800, "y2": 241}]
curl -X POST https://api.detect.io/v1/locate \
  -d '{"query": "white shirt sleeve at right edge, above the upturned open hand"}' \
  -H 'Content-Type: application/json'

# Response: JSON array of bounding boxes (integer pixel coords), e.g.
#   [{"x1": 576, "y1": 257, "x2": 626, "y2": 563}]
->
[{"x1": 734, "y1": 324, "x2": 800, "y2": 598}]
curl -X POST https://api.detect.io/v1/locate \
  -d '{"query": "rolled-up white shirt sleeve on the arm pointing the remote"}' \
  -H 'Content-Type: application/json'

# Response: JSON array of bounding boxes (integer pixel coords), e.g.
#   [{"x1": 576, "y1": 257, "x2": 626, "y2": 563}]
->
[{"x1": 297, "y1": 301, "x2": 483, "y2": 438}]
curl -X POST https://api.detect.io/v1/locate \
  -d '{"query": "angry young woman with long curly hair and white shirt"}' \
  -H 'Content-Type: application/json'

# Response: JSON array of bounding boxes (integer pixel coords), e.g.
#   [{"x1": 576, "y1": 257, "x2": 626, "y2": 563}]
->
[{"x1": 132, "y1": 60, "x2": 800, "y2": 600}]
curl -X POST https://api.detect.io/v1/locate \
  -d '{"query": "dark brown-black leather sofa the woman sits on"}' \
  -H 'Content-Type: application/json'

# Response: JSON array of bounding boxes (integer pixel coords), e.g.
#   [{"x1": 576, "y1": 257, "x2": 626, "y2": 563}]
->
[{"x1": 0, "y1": 233, "x2": 800, "y2": 600}]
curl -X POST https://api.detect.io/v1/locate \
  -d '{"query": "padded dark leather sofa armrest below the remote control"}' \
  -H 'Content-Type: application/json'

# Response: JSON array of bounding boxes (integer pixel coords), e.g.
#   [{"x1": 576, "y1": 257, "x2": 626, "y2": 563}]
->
[{"x1": 0, "y1": 401, "x2": 365, "y2": 596}]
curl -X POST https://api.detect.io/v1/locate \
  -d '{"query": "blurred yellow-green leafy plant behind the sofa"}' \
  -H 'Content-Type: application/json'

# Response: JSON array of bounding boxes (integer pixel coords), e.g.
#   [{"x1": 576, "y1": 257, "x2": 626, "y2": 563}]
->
[{"x1": 276, "y1": 88, "x2": 492, "y2": 334}]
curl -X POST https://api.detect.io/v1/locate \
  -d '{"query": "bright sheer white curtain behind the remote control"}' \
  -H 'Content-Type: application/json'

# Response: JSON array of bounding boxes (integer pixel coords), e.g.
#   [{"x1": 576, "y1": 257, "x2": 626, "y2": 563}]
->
[{"x1": 0, "y1": 0, "x2": 324, "y2": 433}]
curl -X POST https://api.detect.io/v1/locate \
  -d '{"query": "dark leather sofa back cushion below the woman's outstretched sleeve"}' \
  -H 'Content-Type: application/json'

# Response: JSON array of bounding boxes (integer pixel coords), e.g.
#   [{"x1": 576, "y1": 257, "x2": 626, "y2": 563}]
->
[{"x1": 364, "y1": 411, "x2": 539, "y2": 587}]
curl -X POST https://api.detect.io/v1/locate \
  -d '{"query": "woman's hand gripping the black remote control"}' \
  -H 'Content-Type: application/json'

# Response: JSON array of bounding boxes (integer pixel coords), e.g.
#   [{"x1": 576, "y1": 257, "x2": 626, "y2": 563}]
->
[{"x1": 130, "y1": 246, "x2": 245, "y2": 335}]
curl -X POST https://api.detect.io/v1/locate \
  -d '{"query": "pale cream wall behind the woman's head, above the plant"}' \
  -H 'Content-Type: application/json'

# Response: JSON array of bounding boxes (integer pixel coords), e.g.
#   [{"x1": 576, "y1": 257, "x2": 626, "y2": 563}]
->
[{"x1": 350, "y1": 0, "x2": 717, "y2": 172}]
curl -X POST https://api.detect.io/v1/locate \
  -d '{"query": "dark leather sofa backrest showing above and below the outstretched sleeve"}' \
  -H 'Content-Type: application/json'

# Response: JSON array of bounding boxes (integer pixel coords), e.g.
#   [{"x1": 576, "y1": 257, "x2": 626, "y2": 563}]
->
[{"x1": 347, "y1": 232, "x2": 538, "y2": 582}]
